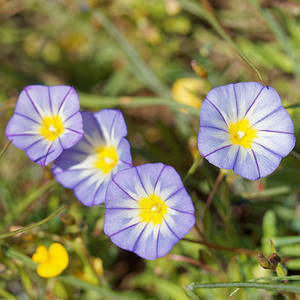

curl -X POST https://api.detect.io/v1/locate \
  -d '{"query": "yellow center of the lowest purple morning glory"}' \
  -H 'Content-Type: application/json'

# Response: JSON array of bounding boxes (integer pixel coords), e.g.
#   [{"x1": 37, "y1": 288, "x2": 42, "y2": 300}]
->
[{"x1": 139, "y1": 194, "x2": 168, "y2": 225}]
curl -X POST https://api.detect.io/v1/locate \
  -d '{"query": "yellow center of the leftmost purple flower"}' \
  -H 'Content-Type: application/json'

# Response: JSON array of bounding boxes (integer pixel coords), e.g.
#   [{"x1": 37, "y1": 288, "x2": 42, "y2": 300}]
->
[{"x1": 40, "y1": 116, "x2": 65, "y2": 141}]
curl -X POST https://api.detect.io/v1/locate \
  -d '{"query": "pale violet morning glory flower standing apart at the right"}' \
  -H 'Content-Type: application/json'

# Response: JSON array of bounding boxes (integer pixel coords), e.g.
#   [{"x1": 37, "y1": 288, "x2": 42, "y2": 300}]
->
[{"x1": 198, "y1": 82, "x2": 295, "y2": 180}]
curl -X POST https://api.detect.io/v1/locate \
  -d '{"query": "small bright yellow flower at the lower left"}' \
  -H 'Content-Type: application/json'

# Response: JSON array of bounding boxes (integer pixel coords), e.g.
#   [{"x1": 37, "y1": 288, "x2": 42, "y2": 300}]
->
[{"x1": 32, "y1": 243, "x2": 69, "y2": 278}]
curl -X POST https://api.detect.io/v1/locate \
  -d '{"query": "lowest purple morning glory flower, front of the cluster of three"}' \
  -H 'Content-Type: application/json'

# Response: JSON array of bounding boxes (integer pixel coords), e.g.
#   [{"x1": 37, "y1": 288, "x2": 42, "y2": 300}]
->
[{"x1": 104, "y1": 163, "x2": 195, "y2": 260}]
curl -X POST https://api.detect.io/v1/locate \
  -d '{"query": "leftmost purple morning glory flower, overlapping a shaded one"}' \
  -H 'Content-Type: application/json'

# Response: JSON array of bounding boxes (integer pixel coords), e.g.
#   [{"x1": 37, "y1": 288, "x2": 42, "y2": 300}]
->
[{"x1": 6, "y1": 85, "x2": 83, "y2": 167}]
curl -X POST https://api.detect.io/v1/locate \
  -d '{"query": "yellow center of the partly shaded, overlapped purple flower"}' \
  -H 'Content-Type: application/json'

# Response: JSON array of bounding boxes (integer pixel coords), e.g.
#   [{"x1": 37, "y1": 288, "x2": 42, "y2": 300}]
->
[{"x1": 94, "y1": 146, "x2": 119, "y2": 174}]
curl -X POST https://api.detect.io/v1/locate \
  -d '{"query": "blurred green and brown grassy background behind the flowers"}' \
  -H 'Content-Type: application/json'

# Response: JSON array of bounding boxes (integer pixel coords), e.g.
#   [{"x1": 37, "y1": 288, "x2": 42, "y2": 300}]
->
[{"x1": 0, "y1": 0, "x2": 300, "y2": 300}]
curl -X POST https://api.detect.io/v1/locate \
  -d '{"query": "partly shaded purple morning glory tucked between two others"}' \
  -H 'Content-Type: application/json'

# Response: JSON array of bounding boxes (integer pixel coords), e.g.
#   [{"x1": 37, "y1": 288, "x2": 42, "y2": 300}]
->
[{"x1": 53, "y1": 109, "x2": 132, "y2": 206}]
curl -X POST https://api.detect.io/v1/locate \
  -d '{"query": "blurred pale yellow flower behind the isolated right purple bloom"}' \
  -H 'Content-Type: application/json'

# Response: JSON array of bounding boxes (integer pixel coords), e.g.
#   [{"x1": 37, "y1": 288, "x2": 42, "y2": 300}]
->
[{"x1": 172, "y1": 78, "x2": 209, "y2": 108}]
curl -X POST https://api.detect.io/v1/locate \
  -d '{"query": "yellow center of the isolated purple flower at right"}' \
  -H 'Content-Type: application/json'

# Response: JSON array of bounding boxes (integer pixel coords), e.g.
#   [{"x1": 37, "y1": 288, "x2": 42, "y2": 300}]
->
[{"x1": 228, "y1": 118, "x2": 257, "y2": 148}]
